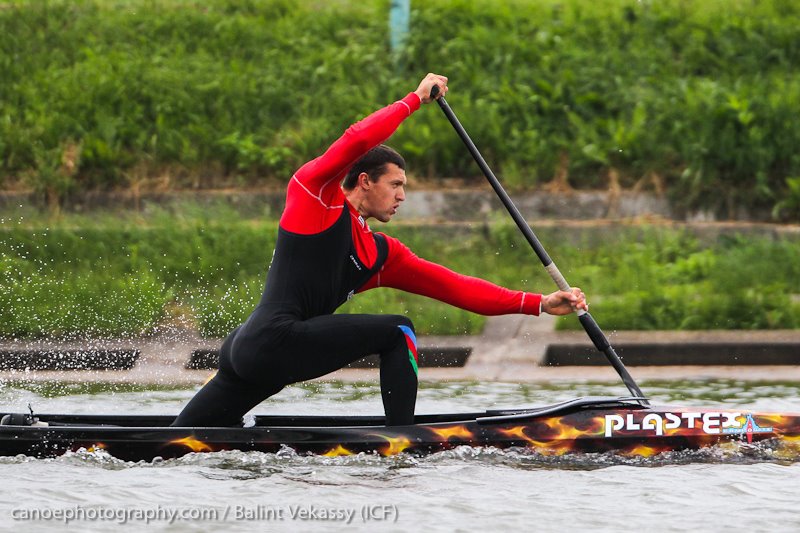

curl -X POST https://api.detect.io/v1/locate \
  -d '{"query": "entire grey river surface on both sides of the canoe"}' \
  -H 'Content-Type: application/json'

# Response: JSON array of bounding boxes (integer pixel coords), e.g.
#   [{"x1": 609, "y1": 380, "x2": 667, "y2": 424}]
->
[{"x1": 0, "y1": 380, "x2": 800, "y2": 532}]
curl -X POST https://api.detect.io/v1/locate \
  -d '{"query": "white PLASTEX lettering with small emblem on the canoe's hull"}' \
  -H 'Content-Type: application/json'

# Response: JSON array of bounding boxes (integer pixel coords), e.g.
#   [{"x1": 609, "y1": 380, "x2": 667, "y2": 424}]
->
[{"x1": 604, "y1": 411, "x2": 773, "y2": 442}]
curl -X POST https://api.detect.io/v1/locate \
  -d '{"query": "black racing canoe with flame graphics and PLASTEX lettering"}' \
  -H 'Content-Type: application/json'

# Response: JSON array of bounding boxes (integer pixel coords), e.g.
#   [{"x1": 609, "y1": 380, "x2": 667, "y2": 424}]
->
[{"x1": 0, "y1": 397, "x2": 800, "y2": 461}]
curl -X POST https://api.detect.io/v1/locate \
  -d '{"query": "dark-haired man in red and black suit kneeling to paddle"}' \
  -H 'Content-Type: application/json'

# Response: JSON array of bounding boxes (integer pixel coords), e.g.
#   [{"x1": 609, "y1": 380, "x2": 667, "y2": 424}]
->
[{"x1": 173, "y1": 74, "x2": 587, "y2": 426}]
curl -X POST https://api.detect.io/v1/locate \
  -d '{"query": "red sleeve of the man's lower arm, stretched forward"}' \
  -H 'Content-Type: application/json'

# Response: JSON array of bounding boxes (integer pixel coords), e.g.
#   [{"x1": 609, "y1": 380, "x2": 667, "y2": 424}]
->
[{"x1": 359, "y1": 236, "x2": 542, "y2": 315}]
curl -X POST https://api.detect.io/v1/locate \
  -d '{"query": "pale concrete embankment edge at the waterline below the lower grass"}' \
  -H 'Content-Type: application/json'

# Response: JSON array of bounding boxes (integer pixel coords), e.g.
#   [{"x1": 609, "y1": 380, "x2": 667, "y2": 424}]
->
[{"x1": 0, "y1": 315, "x2": 800, "y2": 386}]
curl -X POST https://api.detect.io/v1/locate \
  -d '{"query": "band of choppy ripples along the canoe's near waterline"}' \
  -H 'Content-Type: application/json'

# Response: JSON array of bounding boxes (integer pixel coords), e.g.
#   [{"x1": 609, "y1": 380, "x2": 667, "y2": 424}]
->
[{"x1": 0, "y1": 432, "x2": 800, "y2": 474}]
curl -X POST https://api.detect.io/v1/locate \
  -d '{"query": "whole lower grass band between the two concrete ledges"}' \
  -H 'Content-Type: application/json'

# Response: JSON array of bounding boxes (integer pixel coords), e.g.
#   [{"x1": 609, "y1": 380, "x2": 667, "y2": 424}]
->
[{"x1": 0, "y1": 206, "x2": 800, "y2": 337}]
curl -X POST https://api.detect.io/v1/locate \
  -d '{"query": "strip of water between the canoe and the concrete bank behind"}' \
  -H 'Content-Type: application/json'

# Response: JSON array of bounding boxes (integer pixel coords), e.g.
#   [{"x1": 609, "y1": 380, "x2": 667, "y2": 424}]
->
[{"x1": 0, "y1": 379, "x2": 800, "y2": 415}]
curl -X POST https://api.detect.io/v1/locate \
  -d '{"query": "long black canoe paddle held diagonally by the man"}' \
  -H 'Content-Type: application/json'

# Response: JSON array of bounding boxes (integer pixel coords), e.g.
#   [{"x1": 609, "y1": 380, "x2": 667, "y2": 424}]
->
[{"x1": 431, "y1": 85, "x2": 650, "y2": 405}]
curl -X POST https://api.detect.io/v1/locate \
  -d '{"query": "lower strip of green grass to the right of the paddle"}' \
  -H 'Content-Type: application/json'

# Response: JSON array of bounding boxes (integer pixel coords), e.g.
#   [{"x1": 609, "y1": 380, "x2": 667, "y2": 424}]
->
[{"x1": 559, "y1": 229, "x2": 800, "y2": 330}]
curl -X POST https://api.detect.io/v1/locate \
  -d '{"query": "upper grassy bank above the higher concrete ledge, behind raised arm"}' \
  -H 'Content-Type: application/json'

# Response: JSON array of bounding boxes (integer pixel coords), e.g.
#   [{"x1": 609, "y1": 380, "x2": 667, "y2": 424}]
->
[{"x1": 0, "y1": 0, "x2": 800, "y2": 220}]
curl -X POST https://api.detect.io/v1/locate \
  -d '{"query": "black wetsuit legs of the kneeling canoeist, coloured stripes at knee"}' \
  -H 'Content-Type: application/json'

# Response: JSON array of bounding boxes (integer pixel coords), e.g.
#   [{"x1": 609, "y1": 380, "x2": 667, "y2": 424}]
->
[{"x1": 173, "y1": 315, "x2": 417, "y2": 426}]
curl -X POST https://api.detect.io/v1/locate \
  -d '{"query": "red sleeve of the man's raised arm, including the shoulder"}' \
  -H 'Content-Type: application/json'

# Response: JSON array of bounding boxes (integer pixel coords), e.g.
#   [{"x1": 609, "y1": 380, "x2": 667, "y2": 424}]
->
[{"x1": 281, "y1": 93, "x2": 421, "y2": 233}]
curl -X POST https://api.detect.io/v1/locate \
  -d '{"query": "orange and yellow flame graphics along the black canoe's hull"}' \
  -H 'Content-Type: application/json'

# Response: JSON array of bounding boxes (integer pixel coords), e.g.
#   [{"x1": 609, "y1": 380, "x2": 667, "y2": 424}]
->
[{"x1": 153, "y1": 409, "x2": 800, "y2": 458}]
